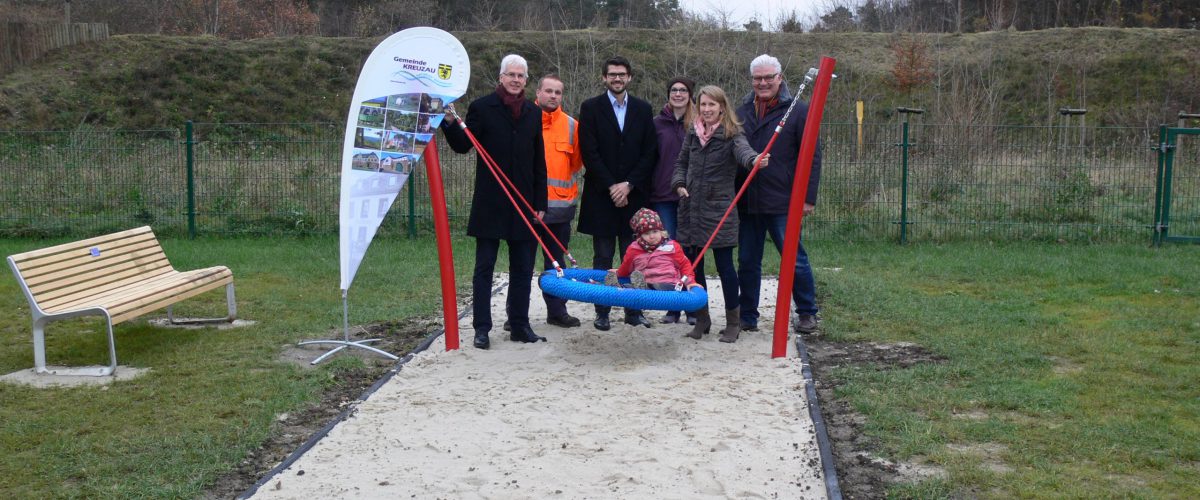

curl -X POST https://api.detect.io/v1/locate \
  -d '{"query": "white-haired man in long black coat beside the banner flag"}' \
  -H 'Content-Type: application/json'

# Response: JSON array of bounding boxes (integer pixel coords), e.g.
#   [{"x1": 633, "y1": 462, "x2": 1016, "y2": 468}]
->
[{"x1": 442, "y1": 54, "x2": 546, "y2": 349}]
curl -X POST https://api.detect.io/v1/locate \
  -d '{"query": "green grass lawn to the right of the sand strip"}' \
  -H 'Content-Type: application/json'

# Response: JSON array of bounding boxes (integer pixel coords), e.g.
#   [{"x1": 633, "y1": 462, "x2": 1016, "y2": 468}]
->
[{"x1": 815, "y1": 243, "x2": 1200, "y2": 498}]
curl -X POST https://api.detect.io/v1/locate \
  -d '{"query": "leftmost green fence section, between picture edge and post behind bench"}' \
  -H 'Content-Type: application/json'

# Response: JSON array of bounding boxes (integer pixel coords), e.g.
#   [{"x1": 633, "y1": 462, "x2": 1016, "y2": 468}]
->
[{"x1": 0, "y1": 127, "x2": 187, "y2": 236}]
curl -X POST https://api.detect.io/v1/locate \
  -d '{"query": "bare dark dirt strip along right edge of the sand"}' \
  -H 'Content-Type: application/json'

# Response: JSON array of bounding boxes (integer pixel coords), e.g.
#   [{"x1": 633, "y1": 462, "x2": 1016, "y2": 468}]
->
[{"x1": 804, "y1": 336, "x2": 946, "y2": 499}]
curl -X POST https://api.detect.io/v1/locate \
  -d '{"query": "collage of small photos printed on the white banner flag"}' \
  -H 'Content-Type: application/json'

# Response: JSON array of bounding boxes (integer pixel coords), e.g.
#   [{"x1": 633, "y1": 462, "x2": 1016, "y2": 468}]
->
[{"x1": 350, "y1": 94, "x2": 452, "y2": 175}]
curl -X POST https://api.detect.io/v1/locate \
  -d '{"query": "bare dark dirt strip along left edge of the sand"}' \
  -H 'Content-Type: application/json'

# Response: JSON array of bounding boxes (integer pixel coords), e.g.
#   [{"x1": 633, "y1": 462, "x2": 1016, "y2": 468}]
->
[{"x1": 202, "y1": 319, "x2": 442, "y2": 499}]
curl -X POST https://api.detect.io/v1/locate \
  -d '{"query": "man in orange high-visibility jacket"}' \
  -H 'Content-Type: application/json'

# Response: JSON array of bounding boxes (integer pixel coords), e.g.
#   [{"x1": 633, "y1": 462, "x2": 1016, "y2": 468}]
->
[{"x1": 538, "y1": 73, "x2": 583, "y2": 329}]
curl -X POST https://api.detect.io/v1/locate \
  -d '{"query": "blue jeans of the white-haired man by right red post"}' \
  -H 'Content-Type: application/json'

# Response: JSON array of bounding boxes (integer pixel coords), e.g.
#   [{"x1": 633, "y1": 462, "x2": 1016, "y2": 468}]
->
[{"x1": 738, "y1": 213, "x2": 817, "y2": 326}]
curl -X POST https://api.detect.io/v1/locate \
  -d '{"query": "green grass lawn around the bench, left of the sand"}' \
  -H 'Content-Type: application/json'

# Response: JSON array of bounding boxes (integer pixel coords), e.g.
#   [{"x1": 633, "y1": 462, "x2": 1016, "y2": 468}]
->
[{"x1": 0, "y1": 237, "x2": 473, "y2": 498}]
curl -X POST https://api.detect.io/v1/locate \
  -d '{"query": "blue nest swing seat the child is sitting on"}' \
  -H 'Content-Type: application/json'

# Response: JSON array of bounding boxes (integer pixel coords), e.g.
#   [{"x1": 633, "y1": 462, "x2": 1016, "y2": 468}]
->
[{"x1": 538, "y1": 269, "x2": 708, "y2": 312}]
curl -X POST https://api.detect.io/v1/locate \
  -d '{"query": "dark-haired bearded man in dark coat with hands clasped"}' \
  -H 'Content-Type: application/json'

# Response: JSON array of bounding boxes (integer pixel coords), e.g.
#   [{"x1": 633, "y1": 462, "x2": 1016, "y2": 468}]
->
[{"x1": 578, "y1": 56, "x2": 659, "y2": 330}]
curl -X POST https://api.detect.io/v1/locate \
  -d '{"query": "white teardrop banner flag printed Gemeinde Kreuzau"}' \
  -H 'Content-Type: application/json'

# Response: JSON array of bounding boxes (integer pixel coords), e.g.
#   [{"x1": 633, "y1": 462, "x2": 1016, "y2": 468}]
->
[{"x1": 340, "y1": 28, "x2": 470, "y2": 291}]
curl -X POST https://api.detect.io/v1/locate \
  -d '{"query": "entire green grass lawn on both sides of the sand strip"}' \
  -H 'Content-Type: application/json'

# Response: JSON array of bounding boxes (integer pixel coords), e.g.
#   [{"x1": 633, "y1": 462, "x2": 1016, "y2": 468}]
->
[{"x1": 0, "y1": 237, "x2": 1200, "y2": 498}]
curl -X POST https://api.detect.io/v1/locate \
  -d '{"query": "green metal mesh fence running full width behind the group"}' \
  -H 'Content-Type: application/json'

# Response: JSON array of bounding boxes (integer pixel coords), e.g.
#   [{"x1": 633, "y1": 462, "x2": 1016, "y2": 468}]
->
[{"x1": 0, "y1": 118, "x2": 1185, "y2": 242}]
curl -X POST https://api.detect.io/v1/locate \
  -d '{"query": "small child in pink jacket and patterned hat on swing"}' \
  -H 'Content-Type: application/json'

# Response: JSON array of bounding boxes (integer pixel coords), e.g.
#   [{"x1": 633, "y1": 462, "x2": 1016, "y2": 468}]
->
[{"x1": 604, "y1": 209, "x2": 698, "y2": 290}]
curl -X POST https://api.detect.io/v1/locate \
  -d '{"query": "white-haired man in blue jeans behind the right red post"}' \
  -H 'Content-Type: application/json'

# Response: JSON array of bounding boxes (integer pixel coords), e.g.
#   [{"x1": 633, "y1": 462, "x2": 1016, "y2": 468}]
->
[{"x1": 737, "y1": 54, "x2": 821, "y2": 333}]
